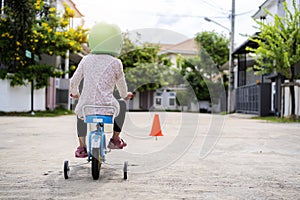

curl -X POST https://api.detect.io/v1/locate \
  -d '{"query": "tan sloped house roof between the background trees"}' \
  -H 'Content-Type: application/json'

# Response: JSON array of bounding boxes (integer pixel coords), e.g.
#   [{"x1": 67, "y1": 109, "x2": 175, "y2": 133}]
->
[{"x1": 159, "y1": 38, "x2": 199, "y2": 55}]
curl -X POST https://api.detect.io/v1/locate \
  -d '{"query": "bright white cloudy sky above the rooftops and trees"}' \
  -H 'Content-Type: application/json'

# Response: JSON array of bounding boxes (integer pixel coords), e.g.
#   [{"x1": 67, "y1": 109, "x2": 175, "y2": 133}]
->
[{"x1": 73, "y1": 0, "x2": 265, "y2": 47}]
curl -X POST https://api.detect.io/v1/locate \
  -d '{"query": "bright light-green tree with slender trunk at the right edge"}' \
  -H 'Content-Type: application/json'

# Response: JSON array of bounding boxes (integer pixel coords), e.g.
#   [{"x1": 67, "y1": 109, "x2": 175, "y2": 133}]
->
[{"x1": 248, "y1": 0, "x2": 300, "y2": 117}]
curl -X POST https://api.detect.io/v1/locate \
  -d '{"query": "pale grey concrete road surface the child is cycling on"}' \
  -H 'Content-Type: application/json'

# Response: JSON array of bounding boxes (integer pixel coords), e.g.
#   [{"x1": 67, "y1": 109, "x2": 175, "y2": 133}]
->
[{"x1": 0, "y1": 112, "x2": 300, "y2": 200}]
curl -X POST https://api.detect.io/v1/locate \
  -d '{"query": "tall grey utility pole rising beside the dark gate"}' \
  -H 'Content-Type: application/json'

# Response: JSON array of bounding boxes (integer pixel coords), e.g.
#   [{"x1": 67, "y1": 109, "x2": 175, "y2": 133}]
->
[{"x1": 227, "y1": 0, "x2": 235, "y2": 113}]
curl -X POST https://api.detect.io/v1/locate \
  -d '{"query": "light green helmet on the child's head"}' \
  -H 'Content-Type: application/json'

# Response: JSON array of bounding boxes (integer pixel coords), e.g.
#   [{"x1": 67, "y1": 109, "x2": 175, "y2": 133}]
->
[{"x1": 89, "y1": 22, "x2": 123, "y2": 56}]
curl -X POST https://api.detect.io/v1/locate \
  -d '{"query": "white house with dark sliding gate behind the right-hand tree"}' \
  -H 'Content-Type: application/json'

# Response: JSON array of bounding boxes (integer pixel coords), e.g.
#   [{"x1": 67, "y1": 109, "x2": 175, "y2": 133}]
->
[{"x1": 234, "y1": 0, "x2": 300, "y2": 116}]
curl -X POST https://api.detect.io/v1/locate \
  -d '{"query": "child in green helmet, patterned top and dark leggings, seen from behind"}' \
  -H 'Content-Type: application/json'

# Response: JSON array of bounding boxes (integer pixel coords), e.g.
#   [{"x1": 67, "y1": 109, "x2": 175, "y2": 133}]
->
[{"x1": 70, "y1": 23, "x2": 133, "y2": 158}]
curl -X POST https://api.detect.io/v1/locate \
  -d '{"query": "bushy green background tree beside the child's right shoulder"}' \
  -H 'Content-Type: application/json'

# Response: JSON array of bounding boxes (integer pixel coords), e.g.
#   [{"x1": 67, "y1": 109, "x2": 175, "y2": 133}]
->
[{"x1": 120, "y1": 34, "x2": 171, "y2": 92}]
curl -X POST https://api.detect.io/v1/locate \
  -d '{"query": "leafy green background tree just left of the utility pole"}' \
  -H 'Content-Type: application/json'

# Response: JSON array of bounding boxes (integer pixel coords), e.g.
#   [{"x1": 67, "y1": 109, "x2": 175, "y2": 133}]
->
[{"x1": 177, "y1": 31, "x2": 229, "y2": 103}]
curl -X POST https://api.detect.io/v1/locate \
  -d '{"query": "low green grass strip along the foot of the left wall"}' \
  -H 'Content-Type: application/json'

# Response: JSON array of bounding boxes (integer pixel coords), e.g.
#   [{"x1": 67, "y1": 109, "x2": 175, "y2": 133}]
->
[{"x1": 0, "y1": 108, "x2": 74, "y2": 117}]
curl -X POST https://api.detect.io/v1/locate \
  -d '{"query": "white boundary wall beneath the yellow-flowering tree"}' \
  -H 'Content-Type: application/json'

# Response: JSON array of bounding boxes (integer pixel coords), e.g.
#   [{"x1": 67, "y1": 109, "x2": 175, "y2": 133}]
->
[{"x1": 0, "y1": 80, "x2": 46, "y2": 112}]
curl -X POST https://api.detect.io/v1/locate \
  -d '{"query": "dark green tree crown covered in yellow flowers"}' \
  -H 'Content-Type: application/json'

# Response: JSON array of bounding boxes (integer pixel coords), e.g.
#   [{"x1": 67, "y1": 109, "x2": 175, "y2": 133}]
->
[{"x1": 0, "y1": 0, "x2": 87, "y2": 88}]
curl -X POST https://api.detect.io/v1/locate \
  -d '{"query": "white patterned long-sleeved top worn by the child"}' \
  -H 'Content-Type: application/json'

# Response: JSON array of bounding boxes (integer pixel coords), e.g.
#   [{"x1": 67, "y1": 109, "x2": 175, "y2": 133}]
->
[{"x1": 70, "y1": 54, "x2": 128, "y2": 118}]
